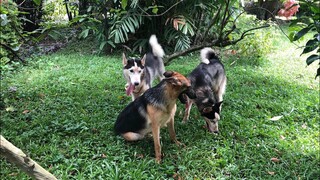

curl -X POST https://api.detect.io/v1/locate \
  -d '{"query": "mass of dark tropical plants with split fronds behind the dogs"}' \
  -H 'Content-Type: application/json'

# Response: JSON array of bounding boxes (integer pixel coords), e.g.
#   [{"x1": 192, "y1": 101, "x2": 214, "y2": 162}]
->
[{"x1": 73, "y1": 0, "x2": 267, "y2": 63}]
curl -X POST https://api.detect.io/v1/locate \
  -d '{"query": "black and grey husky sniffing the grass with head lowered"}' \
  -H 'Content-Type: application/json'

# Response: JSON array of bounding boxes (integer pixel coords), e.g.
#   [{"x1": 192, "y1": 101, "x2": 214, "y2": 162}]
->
[{"x1": 180, "y1": 48, "x2": 227, "y2": 133}]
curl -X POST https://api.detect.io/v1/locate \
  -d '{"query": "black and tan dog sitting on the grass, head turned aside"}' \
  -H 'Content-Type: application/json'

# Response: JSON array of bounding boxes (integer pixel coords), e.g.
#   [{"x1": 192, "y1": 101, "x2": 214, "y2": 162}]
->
[{"x1": 114, "y1": 71, "x2": 195, "y2": 162}]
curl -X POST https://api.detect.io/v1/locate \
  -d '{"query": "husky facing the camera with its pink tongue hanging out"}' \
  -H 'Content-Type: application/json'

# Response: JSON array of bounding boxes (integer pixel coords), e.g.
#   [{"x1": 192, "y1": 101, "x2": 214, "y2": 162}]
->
[{"x1": 122, "y1": 35, "x2": 165, "y2": 101}]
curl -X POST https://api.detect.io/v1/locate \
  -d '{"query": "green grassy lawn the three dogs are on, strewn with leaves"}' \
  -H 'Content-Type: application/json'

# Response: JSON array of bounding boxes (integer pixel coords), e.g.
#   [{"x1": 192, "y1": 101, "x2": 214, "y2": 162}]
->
[{"x1": 0, "y1": 25, "x2": 320, "y2": 180}]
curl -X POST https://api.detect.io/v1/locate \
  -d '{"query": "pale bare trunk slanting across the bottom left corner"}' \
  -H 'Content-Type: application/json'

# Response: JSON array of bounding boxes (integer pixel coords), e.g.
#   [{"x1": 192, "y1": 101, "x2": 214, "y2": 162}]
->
[{"x1": 0, "y1": 135, "x2": 57, "y2": 180}]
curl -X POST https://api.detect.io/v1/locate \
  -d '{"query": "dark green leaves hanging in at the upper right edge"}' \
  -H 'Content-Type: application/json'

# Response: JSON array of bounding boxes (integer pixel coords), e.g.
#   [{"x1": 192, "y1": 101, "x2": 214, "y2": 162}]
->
[{"x1": 289, "y1": 0, "x2": 320, "y2": 77}]
